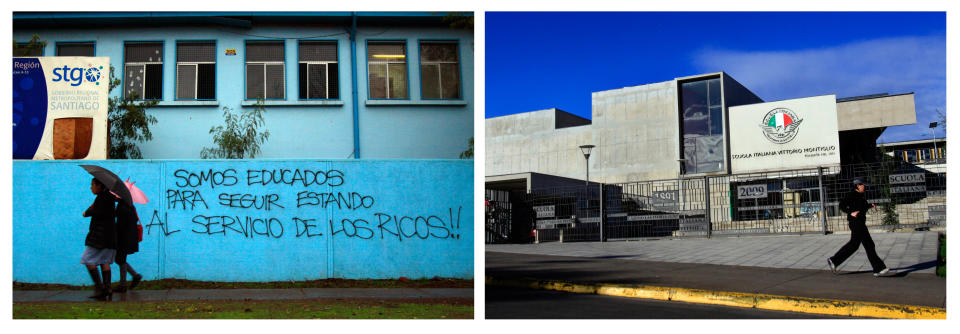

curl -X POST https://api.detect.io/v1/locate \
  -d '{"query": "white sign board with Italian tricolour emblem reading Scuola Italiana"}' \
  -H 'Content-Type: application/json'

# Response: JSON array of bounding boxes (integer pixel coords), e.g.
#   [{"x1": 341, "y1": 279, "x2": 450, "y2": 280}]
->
[{"x1": 729, "y1": 95, "x2": 840, "y2": 173}]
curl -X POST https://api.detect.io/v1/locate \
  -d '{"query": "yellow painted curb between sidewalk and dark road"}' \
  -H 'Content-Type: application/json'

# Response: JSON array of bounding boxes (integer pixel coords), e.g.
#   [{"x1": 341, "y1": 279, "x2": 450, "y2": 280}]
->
[{"x1": 486, "y1": 276, "x2": 947, "y2": 319}]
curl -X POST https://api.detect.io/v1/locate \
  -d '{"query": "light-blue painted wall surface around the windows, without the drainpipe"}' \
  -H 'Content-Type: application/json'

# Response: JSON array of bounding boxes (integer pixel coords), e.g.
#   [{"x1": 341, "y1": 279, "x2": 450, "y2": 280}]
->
[{"x1": 13, "y1": 18, "x2": 474, "y2": 159}]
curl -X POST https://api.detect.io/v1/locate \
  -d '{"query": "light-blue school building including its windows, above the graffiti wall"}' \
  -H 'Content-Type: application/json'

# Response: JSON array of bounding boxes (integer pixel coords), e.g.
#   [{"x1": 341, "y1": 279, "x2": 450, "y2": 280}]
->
[{"x1": 13, "y1": 12, "x2": 474, "y2": 159}]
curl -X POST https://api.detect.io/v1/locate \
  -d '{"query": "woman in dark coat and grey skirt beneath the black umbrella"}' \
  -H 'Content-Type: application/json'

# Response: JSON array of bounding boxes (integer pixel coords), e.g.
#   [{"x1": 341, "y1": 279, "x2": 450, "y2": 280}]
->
[{"x1": 80, "y1": 179, "x2": 117, "y2": 300}]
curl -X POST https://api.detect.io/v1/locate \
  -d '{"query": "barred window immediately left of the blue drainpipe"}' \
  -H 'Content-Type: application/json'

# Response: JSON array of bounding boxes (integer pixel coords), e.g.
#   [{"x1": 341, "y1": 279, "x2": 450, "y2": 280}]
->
[{"x1": 298, "y1": 41, "x2": 340, "y2": 100}]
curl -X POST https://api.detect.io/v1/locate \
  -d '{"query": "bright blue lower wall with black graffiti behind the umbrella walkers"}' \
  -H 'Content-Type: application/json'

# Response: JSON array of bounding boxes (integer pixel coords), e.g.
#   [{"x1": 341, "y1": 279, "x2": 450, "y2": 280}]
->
[{"x1": 12, "y1": 160, "x2": 474, "y2": 285}]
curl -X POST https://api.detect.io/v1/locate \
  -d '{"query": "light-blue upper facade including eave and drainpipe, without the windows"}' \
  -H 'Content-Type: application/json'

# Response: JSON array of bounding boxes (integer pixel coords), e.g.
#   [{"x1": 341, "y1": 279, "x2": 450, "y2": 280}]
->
[{"x1": 13, "y1": 12, "x2": 474, "y2": 159}]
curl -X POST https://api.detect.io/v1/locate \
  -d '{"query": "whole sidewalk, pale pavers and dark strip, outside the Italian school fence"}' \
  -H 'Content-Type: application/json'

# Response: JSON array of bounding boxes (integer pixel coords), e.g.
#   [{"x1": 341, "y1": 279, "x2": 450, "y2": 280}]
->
[{"x1": 485, "y1": 232, "x2": 946, "y2": 317}]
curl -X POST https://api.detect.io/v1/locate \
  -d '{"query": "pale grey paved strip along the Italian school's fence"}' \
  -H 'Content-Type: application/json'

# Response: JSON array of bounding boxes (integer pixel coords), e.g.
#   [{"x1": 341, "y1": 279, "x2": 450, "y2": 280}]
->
[{"x1": 486, "y1": 231, "x2": 937, "y2": 273}]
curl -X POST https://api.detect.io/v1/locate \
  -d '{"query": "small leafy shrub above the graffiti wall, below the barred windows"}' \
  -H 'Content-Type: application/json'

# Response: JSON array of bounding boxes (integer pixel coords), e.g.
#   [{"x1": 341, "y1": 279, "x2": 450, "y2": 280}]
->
[{"x1": 200, "y1": 97, "x2": 270, "y2": 159}]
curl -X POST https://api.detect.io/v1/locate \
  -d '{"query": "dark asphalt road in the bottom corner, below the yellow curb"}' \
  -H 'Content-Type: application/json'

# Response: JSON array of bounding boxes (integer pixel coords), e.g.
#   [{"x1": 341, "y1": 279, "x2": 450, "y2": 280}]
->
[{"x1": 486, "y1": 285, "x2": 849, "y2": 319}]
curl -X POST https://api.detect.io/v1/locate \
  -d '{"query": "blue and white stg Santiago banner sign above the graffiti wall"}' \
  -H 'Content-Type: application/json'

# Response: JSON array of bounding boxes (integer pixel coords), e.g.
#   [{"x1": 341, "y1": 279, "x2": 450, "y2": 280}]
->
[{"x1": 13, "y1": 57, "x2": 110, "y2": 160}]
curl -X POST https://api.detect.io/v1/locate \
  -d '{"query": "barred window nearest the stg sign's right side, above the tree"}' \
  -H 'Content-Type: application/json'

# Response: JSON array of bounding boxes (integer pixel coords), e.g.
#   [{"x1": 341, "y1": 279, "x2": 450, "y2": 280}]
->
[{"x1": 123, "y1": 42, "x2": 163, "y2": 100}]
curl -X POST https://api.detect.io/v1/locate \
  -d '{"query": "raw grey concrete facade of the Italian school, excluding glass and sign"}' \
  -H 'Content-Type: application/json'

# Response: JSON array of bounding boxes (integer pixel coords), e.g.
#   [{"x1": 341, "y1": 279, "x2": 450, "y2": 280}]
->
[{"x1": 485, "y1": 72, "x2": 916, "y2": 183}]
